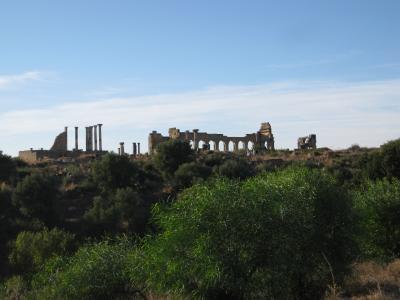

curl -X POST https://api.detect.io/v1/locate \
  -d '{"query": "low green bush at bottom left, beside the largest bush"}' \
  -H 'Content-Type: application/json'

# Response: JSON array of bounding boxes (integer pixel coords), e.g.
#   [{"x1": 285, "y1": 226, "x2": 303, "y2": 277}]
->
[{"x1": 31, "y1": 238, "x2": 134, "y2": 300}]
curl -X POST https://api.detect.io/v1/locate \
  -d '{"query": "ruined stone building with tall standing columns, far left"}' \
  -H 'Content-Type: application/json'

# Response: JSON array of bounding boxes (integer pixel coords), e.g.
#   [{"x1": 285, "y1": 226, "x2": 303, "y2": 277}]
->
[{"x1": 19, "y1": 124, "x2": 105, "y2": 163}]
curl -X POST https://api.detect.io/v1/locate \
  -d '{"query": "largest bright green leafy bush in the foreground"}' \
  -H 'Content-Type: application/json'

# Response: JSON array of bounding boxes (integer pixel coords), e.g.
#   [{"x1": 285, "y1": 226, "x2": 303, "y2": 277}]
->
[{"x1": 131, "y1": 168, "x2": 354, "y2": 299}]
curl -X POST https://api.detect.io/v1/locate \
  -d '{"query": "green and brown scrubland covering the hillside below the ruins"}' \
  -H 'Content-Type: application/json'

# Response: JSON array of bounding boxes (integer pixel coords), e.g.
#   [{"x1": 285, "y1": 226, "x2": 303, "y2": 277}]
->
[{"x1": 0, "y1": 140, "x2": 400, "y2": 299}]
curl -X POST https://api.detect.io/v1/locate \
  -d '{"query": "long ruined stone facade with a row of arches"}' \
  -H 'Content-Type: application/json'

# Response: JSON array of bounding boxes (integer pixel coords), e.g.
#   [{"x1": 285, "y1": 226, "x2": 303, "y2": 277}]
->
[{"x1": 149, "y1": 122, "x2": 275, "y2": 154}]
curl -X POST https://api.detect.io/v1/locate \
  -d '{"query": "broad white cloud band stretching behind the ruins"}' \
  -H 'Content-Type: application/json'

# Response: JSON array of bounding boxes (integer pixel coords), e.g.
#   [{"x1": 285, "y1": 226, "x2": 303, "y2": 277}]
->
[{"x1": 0, "y1": 79, "x2": 400, "y2": 156}]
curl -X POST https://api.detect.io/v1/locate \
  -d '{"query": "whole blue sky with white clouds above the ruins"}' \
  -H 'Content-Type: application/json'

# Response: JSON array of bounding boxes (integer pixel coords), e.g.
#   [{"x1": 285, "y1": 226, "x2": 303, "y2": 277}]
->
[{"x1": 0, "y1": 0, "x2": 400, "y2": 156}]
